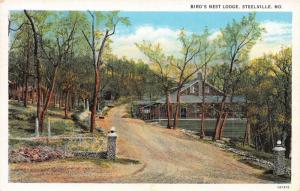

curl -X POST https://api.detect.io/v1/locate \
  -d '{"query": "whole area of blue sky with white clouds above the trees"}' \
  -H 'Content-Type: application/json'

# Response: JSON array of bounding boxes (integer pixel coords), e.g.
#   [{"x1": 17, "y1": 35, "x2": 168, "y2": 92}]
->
[{"x1": 112, "y1": 12, "x2": 292, "y2": 60}]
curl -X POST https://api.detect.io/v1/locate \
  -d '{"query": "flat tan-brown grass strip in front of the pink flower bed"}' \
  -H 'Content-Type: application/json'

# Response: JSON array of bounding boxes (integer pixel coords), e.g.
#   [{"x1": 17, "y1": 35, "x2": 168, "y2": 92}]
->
[{"x1": 9, "y1": 158, "x2": 141, "y2": 183}]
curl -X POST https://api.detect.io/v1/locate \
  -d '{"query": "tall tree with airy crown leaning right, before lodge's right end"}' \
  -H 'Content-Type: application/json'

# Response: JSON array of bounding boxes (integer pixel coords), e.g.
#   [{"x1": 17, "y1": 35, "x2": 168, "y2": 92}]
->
[{"x1": 213, "y1": 13, "x2": 264, "y2": 140}]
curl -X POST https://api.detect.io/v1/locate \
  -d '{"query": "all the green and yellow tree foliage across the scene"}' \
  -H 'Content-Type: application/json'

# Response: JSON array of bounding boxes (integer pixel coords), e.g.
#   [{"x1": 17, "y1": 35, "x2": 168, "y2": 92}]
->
[{"x1": 9, "y1": 11, "x2": 292, "y2": 155}]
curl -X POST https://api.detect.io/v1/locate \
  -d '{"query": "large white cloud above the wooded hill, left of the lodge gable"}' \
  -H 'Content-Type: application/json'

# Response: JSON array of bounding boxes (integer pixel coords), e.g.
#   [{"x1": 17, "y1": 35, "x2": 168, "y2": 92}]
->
[{"x1": 112, "y1": 26, "x2": 180, "y2": 60}]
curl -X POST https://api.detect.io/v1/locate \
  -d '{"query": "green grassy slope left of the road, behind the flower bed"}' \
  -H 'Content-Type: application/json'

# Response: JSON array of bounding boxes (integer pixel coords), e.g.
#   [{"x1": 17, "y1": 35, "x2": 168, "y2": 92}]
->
[{"x1": 9, "y1": 101, "x2": 106, "y2": 152}]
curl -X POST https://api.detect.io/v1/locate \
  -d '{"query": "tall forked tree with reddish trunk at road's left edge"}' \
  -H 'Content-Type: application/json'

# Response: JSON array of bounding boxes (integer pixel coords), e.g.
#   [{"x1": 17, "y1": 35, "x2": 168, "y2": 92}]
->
[{"x1": 82, "y1": 11, "x2": 130, "y2": 132}]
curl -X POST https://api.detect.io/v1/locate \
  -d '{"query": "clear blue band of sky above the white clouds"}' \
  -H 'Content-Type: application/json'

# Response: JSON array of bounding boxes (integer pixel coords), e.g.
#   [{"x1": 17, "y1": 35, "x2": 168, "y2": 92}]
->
[{"x1": 116, "y1": 12, "x2": 292, "y2": 32}]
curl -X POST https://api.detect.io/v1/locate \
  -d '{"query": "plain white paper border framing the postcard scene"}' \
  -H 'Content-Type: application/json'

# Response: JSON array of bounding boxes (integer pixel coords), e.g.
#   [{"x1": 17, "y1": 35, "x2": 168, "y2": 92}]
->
[{"x1": 0, "y1": 0, "x2": 300, "y2": 191}]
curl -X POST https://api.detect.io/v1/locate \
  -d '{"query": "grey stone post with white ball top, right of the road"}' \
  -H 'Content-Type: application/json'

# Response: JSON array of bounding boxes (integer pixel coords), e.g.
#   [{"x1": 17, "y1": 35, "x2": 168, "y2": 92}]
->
[{"x1": 273, "y1": 140, "x2": 285, "y2": 175}]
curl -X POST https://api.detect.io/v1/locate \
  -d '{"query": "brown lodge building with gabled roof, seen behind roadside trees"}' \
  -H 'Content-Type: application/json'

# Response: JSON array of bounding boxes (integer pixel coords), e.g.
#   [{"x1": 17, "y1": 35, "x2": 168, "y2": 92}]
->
[{"x1": 133, "y1": 73, "x2": 245, "y2": 120}]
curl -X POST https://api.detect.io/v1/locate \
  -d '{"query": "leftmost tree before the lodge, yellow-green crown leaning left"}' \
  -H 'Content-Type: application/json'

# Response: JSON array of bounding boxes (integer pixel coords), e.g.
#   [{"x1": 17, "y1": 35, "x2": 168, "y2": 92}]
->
[{"x1": 136, "y1": 41, "x2": 172, "y2": 129}]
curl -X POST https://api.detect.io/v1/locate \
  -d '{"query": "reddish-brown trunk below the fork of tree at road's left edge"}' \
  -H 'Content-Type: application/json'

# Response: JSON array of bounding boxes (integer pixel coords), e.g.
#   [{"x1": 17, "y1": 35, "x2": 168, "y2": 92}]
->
[{"x1": 90, "y1": 66, "x2": 100, "y2": 133}]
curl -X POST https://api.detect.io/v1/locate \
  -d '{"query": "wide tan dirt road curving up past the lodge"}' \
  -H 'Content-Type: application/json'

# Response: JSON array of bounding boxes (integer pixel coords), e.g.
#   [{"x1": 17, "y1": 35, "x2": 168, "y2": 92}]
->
[{"x1": 106, "y1": 106, "x2": 270, "y2": 183}]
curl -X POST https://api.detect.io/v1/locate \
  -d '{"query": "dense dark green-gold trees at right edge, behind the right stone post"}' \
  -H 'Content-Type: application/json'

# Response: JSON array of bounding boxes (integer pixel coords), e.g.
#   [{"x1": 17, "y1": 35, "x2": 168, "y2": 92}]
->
[{"x1": 234, "y1": 48, "x2": 291, "y2": 158}]
